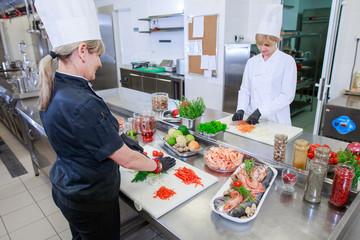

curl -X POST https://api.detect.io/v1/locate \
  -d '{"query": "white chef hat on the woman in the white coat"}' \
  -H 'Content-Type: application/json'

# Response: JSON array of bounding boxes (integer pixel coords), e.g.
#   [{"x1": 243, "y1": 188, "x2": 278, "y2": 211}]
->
[{"x1": 256, "y1": 4, "x2": 283, "y2": 39}]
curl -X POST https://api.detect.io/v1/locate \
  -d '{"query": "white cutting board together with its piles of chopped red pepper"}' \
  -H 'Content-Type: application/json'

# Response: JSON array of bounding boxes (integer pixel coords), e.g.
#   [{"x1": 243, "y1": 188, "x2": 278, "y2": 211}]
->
[{"x1": 120, "y1": 146, "x2": 218, "y2": 218}]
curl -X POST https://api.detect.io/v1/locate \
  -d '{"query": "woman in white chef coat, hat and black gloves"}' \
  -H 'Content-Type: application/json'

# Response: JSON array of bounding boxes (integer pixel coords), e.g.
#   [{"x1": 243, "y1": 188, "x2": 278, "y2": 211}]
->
[{"x1": 233, "y1": 4, "x2": 297, "y2": 125}]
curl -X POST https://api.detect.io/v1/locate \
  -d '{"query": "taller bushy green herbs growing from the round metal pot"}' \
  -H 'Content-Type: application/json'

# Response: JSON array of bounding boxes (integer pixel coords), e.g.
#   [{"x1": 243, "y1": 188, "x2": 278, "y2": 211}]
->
[{"x1": 175, "y1": 97, "x2": 206, "y2": 119}]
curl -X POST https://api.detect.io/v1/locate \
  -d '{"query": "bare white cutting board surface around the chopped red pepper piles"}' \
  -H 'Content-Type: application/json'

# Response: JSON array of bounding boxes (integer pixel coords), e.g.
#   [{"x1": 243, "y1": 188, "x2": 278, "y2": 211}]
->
[{"x1": 120, "y1": 146, "x2": 218, "y2": 218}]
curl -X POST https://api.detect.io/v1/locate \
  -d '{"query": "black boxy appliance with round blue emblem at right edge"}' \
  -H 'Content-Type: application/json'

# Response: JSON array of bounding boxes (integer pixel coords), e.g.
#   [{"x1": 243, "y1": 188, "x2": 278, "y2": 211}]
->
[{"x1": 322, "y1": 95, "x2": 360, "y2": 142}]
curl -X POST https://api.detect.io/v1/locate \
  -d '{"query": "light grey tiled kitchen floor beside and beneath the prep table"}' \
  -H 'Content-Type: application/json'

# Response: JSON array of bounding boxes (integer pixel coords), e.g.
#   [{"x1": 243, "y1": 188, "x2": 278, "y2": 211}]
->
[{"x1": 0, "y1": 122, "x2": 166, "y2": 240}]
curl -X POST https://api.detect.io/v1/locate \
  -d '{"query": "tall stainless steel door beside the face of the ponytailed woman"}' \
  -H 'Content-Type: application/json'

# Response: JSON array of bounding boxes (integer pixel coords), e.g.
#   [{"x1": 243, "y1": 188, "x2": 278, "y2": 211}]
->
[{"x1": 91, "y1": 14, "x2": 118, "y2": 91}]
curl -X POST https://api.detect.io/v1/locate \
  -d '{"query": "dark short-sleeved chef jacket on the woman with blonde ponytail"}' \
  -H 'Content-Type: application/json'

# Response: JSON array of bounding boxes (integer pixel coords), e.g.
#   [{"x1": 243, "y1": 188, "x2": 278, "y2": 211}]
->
[{"x1": 40, "y1": 72, "x2": 124, "y2": 204}]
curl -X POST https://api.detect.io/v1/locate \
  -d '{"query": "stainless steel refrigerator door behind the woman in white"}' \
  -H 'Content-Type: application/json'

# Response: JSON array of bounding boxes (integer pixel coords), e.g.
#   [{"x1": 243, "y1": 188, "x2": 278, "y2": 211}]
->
[{"x1": 223, "y1": 44, "x2": 251, "y2": 113}]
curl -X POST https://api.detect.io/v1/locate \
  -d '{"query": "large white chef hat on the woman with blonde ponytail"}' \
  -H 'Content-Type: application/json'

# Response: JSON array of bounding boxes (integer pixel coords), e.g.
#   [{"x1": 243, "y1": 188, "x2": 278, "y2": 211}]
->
[{"x1": 35, "y1": 0, "x2": 101, "y2": 48}]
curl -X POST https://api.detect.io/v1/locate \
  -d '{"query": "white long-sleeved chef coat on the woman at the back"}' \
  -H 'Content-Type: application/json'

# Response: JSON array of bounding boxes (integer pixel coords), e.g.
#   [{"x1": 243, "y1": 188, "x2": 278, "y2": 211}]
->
[{"x1": 237, "y1": 49, "x2": 297, "y2": 125}]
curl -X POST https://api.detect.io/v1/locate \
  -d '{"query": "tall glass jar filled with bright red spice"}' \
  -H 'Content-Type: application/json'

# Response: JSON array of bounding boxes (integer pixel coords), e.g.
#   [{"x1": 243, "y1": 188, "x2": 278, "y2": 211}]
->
[{"x1": 330, "y1": 163, "x2": 355, "y2": 207}]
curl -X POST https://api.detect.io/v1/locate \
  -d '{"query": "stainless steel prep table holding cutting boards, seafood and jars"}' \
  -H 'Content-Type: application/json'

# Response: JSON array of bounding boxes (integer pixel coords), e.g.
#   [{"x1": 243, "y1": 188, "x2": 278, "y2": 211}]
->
[{"x1": 16, "y1": 88, "x2": 360, "y2": 239}]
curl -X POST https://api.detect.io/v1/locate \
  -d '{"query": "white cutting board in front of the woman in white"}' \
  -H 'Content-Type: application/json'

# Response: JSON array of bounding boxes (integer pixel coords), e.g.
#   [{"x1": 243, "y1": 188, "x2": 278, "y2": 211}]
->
[{"x1": 218, "y1": 115, "x2": 303, "y2": 146}]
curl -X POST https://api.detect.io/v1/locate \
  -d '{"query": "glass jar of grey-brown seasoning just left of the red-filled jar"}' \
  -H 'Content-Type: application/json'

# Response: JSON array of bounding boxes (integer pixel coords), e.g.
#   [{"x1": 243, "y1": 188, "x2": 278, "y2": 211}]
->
[{"x1": 304, "y1": 157, "x2": 328, "y2": 203}]
